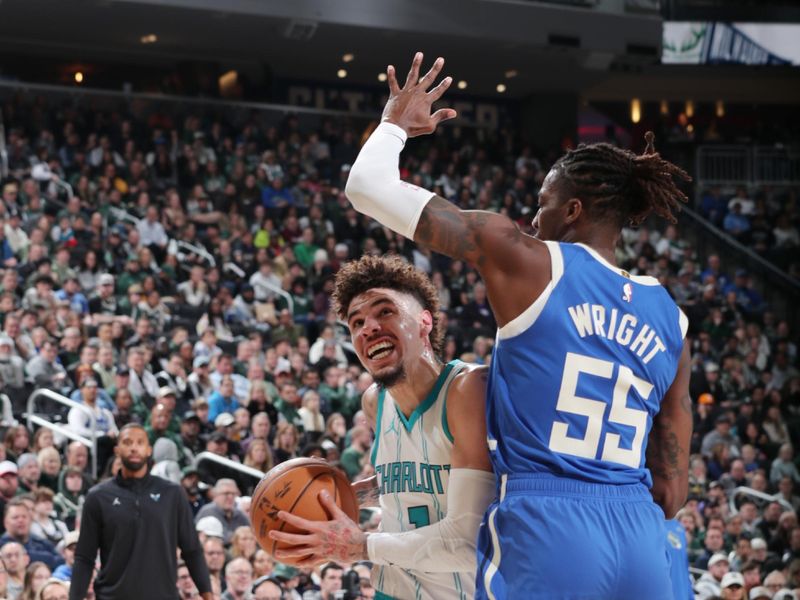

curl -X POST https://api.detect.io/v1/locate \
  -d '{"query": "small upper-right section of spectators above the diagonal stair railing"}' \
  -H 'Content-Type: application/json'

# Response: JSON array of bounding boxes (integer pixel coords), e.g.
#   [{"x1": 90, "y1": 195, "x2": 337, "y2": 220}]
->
[{"x1": 698, "y1": 185, "x2": 800, "y2": 279}]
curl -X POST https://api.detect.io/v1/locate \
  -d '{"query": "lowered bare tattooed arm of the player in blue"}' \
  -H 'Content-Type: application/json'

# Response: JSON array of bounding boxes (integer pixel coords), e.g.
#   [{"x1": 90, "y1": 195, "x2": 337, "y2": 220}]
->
[{"x1": 645, "y1": 342, "x2": 692, "y2": 519}]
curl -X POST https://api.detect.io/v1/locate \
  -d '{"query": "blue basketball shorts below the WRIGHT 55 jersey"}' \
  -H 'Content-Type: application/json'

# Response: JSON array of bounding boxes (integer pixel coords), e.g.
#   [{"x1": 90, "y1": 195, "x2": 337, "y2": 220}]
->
[{"x1": 475, "y1": 475, "x2": 672, "y2": 600}]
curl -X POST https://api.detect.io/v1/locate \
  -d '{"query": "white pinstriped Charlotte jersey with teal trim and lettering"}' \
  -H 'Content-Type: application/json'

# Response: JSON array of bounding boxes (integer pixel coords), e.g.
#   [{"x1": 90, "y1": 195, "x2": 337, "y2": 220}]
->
[{"x1": 371, "y1": 360, "x2": 475, "y2": 600}]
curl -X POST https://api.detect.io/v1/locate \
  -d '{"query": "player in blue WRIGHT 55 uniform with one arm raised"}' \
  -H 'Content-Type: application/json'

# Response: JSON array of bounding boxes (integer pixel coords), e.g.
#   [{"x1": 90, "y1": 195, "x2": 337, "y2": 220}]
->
[{"x1": 346, "y1": 53, "x2": 692, "y2": 600}]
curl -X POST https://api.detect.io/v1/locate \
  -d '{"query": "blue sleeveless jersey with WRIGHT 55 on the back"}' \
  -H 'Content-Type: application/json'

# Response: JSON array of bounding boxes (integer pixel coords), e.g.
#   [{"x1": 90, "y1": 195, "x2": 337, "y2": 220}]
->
[{"x1": 487, "y1": 242, "x2": 687, "y2": 487}]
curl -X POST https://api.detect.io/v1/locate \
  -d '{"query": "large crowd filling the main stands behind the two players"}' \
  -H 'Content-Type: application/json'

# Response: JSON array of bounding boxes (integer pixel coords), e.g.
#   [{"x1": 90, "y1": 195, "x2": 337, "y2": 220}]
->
[{"x1": 0, "y1": 90, "x2": 800, "y2": 600}]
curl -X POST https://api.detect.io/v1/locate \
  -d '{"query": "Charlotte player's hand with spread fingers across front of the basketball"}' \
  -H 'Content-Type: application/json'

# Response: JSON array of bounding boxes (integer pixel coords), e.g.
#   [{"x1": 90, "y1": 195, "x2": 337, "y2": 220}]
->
[{"x1": 269, "y1": 490, "x2": 368, "y2": 568}]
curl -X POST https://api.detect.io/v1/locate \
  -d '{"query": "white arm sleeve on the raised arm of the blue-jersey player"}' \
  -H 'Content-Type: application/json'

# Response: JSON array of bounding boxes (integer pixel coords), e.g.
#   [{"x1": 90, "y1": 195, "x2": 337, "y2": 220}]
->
[{"x1": 344, "y1": 123, "x2": 434, "y2": 240}]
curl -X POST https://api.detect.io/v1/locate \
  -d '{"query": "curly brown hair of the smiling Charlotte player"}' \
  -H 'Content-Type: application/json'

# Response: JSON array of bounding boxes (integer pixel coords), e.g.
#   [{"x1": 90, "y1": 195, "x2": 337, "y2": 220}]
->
[{"x1": 331, "y1": 255, "x2": 444, "y2": 356}]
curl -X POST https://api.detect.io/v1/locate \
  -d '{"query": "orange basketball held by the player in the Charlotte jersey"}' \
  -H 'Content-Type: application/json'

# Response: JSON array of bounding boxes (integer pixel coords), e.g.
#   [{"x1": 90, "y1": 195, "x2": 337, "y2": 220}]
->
[{"x1": 250, "y1": 458, "x2": 358, "y2": 562}]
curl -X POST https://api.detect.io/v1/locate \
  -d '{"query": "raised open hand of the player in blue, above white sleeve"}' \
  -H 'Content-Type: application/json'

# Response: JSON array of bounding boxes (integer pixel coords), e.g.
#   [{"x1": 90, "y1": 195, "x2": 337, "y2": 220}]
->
[{"x1": 383, "y1": 52, "x2": 456, "y2": 137}]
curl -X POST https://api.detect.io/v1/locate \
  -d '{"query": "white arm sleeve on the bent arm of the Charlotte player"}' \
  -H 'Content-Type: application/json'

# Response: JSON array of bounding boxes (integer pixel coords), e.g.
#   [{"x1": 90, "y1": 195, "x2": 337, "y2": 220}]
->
[{"x1": 367, "y1": 469, "x2": 495, "y2": 573}]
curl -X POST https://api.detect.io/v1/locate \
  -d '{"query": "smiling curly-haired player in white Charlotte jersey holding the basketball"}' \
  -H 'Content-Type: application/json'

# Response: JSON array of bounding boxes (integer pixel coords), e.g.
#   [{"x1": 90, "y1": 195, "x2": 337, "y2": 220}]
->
[{"x1": 270, "y1": 256, "x2": 495, "y2": 600}]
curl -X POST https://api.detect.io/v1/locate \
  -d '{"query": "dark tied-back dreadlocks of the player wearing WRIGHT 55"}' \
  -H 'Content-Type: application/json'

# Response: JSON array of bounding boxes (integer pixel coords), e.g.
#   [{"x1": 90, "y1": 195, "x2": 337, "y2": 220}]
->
[{"x1": 553, "y1": 131, "x2": 692, "y2": 227}]
